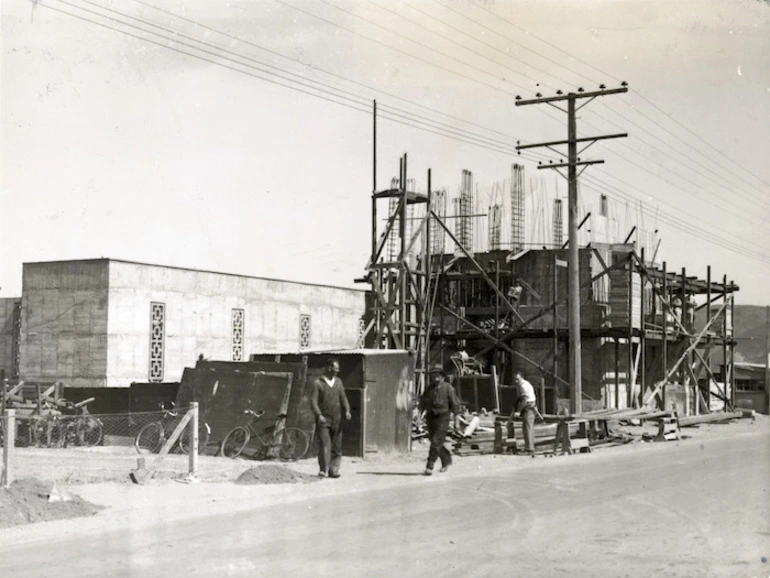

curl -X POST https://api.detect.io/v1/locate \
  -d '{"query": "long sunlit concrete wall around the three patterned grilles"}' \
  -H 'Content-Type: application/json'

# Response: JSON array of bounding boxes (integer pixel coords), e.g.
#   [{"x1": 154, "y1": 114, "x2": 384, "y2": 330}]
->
[{"x1": 106, "y1": 261, "x2": 365, "y2": 387}]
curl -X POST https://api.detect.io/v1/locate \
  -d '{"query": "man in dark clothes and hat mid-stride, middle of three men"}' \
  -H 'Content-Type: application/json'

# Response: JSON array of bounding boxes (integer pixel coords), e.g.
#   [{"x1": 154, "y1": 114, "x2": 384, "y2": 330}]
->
[{"x1": 419, "y1": 365, "x2": 460, "y2": 476}]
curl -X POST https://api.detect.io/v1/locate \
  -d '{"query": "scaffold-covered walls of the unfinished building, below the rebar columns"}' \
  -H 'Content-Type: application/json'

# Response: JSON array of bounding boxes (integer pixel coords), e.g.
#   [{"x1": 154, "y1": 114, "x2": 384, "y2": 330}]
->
[{"x1": 414, "y1": 244, "x2": 739, "y2": 415}]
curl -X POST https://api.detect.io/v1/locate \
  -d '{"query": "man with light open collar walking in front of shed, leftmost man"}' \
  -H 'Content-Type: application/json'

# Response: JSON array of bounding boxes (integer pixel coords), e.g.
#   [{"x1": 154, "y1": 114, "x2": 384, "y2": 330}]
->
[{"x1": 310, "y1": 359, "x2": 350, "y2": 478}]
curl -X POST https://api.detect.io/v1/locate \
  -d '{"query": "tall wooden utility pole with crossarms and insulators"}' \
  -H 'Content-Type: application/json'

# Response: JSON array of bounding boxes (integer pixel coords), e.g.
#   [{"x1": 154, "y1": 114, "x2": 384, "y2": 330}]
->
[{"x1": 516, "y1": 82, "x2": 631, "y2": 414}]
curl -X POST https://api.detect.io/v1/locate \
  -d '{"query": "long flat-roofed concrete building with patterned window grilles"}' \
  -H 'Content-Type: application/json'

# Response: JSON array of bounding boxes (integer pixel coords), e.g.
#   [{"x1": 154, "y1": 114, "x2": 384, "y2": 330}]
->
[{"x1": 5, "y1": 259, "x2": 365, "y2": 387}]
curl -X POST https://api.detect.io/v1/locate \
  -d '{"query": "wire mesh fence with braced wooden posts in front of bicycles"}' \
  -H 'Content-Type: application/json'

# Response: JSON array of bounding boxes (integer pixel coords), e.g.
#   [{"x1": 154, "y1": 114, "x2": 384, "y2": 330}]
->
[{"x1": 0, "y1": 403, "x2": 204, "y2": 487}]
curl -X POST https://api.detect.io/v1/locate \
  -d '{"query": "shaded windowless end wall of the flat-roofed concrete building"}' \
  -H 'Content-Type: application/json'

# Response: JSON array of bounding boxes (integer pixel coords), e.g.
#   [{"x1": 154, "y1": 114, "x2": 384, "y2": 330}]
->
[{"x1": 19, "y1": 260, "x2": 108, "y2": 387}]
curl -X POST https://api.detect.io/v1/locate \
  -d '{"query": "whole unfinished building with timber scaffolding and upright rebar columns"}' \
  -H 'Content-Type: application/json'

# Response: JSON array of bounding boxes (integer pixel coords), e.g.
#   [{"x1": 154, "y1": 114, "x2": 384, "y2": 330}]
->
[{"x1": 362, "y1": 155, "x2": 738, "y2": 415}]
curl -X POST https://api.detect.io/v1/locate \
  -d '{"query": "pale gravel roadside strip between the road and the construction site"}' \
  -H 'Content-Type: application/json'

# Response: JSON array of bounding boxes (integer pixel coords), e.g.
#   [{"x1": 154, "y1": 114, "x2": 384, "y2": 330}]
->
[{"x1": 0, "y1": 415, "x2": 770, "y2": 532}]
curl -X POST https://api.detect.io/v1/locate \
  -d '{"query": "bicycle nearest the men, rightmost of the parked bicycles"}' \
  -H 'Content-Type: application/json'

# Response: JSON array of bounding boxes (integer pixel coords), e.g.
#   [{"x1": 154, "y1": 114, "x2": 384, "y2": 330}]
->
[{"x1": 220, "y1": 409, "x2": 310, "y2": 461}]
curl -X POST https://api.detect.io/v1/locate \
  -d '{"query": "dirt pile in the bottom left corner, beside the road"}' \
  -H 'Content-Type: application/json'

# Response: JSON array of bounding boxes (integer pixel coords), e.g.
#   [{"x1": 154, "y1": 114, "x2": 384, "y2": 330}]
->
[{"x1": 0, "y1": 478, "x2": 102, "y2": 528}]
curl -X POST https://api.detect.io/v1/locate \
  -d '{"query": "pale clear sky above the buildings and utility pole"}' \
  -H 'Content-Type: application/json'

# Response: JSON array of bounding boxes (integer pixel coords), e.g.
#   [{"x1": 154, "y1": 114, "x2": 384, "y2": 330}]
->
[{"x1": 0, "y1": 0, "x2": 770, "y2": 305}]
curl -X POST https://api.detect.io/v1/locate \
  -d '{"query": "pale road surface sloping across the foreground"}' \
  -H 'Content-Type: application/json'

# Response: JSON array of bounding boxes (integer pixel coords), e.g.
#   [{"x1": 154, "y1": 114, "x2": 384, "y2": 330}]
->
[{"x1": 0, "y1": 434, "x2": 770, "y2": 578}]
